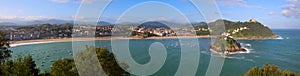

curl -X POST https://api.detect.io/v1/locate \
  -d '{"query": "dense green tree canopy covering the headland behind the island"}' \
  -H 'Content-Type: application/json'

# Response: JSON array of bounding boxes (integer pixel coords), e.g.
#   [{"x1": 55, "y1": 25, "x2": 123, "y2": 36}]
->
[{"x1": 194, "y1": 19, "x2": 275, "y2": 37}]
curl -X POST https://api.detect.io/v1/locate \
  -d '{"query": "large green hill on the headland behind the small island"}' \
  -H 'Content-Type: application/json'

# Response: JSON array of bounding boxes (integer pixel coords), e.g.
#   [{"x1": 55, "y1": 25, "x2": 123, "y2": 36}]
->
[{"x1": 195, "y1": 20, "x2": 276, "y2": 38}]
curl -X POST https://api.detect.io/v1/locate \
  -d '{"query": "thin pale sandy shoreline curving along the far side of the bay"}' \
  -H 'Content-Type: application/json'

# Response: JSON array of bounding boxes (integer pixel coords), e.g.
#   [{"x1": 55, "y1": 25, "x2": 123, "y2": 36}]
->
[{"x1": 10, "y1": 35, "x2": 283, "y2": 47}]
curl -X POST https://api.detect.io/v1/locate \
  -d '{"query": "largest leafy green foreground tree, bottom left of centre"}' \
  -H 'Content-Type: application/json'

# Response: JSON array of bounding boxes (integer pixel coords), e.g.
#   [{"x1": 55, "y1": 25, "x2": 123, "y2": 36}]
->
[{"x1": 75, "y1": 46, "x2": 129, "y2": 76}]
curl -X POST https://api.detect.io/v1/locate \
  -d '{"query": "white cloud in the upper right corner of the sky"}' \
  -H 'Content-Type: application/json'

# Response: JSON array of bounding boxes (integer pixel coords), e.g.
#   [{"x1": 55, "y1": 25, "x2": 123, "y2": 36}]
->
[{"x1": 281, "y1": 0, "x2": 300, "y2": 17}]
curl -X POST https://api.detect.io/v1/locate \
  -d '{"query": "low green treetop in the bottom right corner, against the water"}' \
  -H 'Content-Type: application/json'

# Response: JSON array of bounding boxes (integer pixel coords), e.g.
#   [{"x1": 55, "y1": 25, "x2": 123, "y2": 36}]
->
[{"x1": 245, "y1": 64, "x2": 300, "y2": 76}]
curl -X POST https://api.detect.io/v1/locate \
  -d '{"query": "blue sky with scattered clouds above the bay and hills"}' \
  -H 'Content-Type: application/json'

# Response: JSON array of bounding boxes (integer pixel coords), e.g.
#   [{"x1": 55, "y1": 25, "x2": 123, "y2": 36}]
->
[{"x1": 0, "y1": 0, "x2": 300, "y2": 29}]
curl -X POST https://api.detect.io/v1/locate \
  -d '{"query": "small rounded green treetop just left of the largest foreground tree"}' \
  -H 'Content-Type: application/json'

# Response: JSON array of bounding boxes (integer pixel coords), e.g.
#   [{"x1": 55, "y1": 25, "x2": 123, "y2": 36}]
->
[{"x1": 51, "y1": 59, "x2": 79, "y2": 76}]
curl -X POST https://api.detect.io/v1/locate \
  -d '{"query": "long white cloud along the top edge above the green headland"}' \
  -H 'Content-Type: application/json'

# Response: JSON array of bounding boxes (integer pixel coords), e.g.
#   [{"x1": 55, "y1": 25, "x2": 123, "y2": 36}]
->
[{"x1": 216, "y1": 0, "x2": 265, "y2": 9}]
